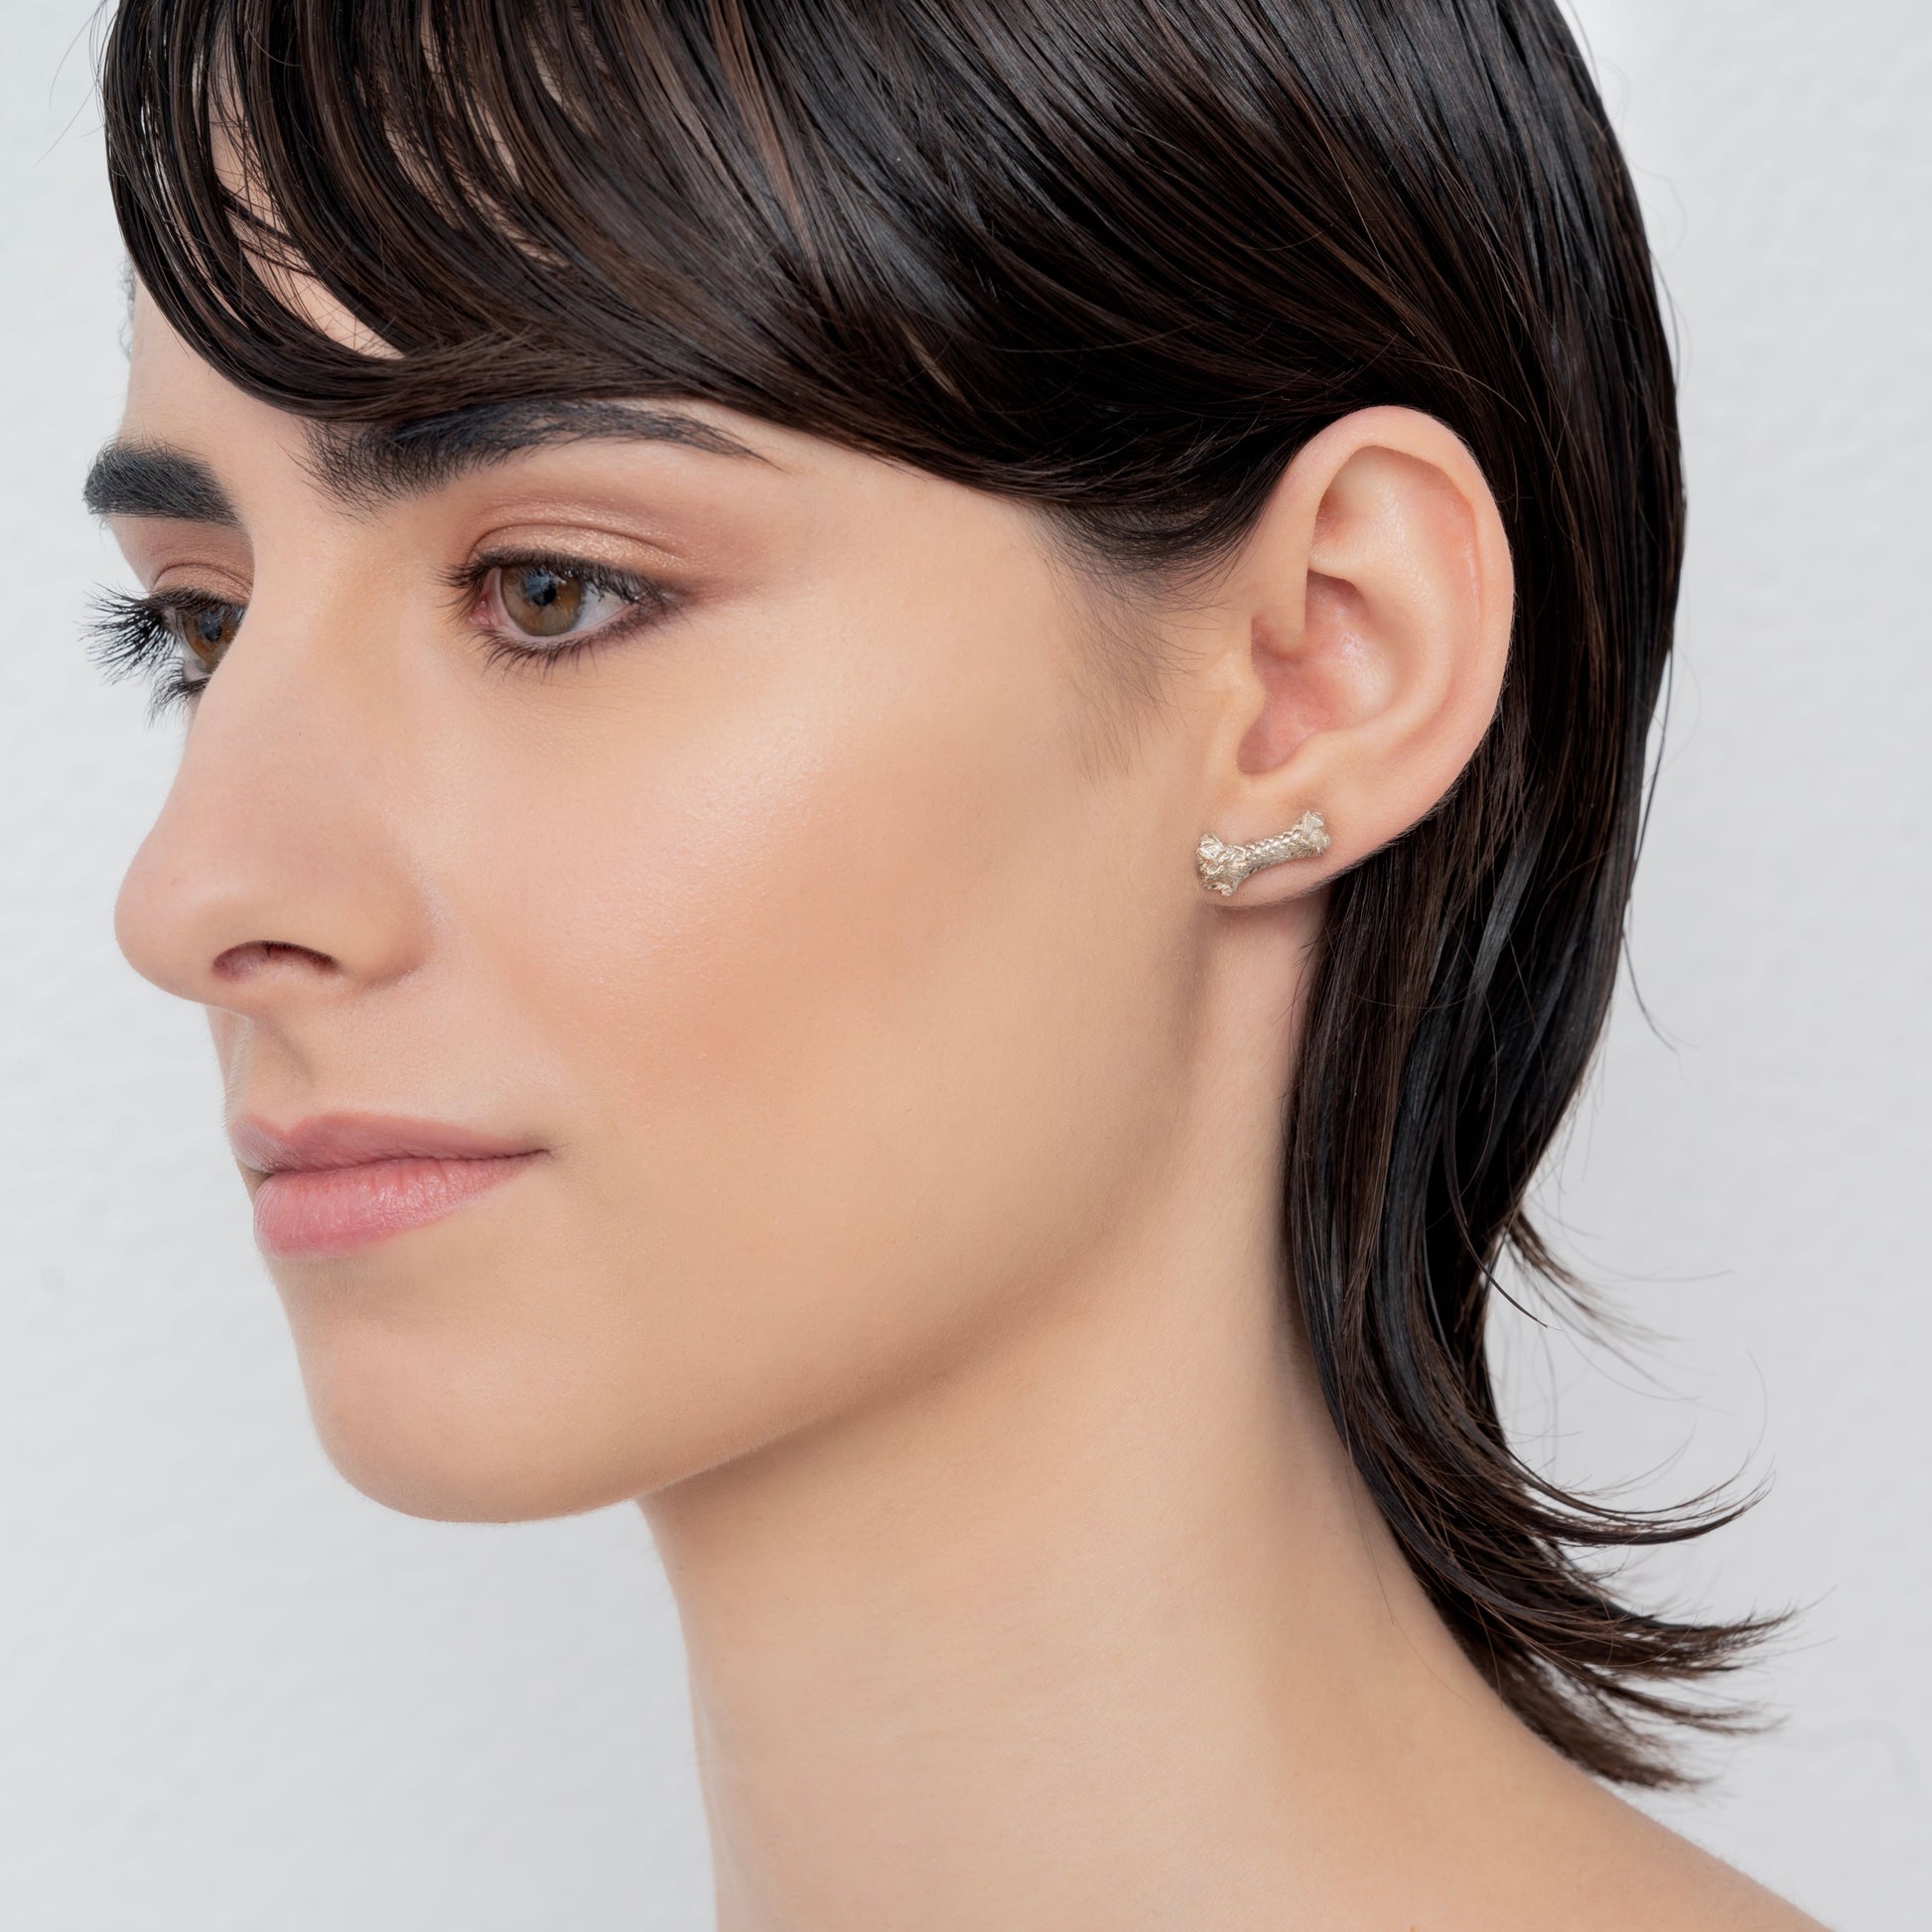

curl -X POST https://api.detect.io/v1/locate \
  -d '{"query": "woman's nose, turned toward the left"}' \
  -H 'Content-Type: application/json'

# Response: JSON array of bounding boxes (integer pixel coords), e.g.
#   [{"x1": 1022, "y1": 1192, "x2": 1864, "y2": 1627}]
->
[{"x1": 114, "y1": 595, "x2": 429, "y2": 1019}]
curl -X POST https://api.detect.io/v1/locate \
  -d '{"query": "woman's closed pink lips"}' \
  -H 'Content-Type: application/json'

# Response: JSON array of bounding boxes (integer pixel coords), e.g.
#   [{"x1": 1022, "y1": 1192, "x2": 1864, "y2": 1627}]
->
[{"x1": 240, "y1": 1113, "x2": 543, "y2": 1256}]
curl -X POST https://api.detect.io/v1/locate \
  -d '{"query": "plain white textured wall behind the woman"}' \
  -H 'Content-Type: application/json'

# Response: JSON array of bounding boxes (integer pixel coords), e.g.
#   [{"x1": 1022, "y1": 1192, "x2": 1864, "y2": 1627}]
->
[{"x1": 0, "y1": 0, "x2": 1932, "y2": 1932}]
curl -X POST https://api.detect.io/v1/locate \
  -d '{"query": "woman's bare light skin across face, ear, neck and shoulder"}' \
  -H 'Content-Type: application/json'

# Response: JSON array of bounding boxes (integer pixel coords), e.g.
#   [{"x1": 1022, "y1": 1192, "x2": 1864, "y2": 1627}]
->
[{"x1": 114, "y1": 298, "x2": 1810, "y2": 1932}]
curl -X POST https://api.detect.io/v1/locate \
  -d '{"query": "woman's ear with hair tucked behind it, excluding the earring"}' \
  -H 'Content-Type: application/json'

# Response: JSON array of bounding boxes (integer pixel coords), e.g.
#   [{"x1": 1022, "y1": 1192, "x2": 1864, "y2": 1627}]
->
[{"x1": 1203, "y1": 408, "x2": 1515, "y2": 904}]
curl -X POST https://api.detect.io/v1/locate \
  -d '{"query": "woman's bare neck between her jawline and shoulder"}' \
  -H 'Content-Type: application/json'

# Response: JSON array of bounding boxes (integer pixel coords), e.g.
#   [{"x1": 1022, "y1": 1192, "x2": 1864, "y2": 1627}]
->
[{"x1": 647, "y1": 907, "x2": 1569, "y2": 1932}]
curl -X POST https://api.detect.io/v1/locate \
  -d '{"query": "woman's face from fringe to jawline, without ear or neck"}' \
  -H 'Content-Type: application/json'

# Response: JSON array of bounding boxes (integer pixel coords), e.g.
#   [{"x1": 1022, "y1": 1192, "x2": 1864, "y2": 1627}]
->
[{"x1": 96, "y1": 300, "x2": 1203, "y2": 1517}]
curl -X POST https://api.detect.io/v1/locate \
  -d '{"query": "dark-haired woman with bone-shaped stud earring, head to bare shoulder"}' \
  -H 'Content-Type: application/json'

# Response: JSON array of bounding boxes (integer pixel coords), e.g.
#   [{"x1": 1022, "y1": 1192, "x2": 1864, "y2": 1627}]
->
[{"x1": 89, "y1": 0, "x2": 1808, "y2": 1932}]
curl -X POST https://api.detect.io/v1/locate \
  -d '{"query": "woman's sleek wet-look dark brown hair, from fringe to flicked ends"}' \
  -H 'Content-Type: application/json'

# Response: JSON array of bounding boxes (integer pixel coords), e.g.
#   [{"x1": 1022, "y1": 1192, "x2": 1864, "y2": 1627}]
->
[{"x1": 104, "y1": 0, "x2": 1762, "y2": 1783}]
